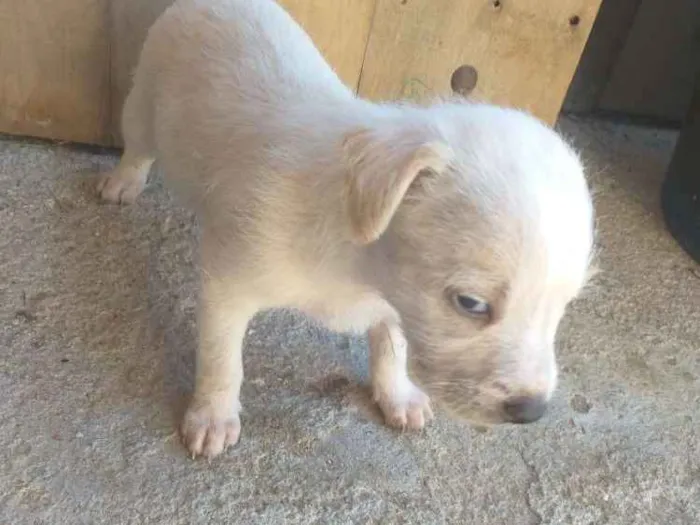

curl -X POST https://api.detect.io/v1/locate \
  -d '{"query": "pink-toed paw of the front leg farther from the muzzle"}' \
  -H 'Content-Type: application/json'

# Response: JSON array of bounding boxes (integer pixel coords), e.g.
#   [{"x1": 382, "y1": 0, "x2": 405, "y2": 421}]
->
[{"x1": 180, "y1": 404, "x2": 241, "y2": 459}]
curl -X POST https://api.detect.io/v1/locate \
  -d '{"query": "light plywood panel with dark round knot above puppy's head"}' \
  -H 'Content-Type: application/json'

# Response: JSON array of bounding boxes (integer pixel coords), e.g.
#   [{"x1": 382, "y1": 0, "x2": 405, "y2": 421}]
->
[{"x1": 360, "y1": 0, "x2": 600, "y2": 123}]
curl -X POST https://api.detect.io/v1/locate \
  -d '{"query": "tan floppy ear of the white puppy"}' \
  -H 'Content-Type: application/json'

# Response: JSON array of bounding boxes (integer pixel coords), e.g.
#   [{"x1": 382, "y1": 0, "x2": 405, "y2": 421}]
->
[{"x1": 343, "y1": 129, "x2": 452, "y2": 244}]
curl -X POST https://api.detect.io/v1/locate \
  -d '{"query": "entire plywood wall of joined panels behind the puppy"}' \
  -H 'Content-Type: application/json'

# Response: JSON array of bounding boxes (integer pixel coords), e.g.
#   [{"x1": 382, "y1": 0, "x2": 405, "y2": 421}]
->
[{"x1": 0, "y1": 0, "x2": 600, "y2": 144}]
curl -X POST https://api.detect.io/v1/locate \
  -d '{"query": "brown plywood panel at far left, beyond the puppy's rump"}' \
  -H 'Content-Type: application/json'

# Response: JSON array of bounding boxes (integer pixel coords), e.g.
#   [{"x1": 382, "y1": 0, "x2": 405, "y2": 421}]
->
[{"x1": 0, "y1": 0, "x2": 109, "y2": 143}]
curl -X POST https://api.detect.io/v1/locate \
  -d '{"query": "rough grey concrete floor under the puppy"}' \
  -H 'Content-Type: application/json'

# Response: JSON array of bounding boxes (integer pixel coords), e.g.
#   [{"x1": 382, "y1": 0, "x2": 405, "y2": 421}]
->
[{"x1": 0, "y1": 116, "x2": 700, "y2": 525}]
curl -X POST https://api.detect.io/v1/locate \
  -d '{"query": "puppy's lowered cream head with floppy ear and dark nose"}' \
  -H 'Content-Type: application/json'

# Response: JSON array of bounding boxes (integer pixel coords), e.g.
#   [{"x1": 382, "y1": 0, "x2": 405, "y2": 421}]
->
[{"x1": 346, "y1": 104, "x2": 593, "y2": 424}]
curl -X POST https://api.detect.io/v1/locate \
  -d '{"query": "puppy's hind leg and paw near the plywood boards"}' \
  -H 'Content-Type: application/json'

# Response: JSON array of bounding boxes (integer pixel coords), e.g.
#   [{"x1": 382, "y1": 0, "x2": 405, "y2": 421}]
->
[{"x1": 97, "y1": 81, "x2": 155, "y2": 204}]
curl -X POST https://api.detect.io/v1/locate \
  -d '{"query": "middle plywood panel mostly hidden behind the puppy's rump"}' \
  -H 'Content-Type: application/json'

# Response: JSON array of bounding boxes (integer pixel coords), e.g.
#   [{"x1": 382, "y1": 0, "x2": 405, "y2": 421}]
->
[{"x1": 111, "y1": 0, "x2": 376, "y2": 143}]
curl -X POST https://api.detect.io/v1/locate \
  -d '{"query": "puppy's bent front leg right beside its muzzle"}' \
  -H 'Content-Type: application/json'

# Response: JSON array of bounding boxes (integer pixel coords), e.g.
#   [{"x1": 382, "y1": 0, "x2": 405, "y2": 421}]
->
[{"x1": 369, "y1": 322, "x2": 433, "y2": 429}]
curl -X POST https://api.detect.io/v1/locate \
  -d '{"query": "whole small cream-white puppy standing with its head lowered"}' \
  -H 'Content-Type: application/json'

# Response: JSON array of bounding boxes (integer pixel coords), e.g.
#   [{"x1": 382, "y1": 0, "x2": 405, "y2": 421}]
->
[{"x1": 100, "y1": 0, "x2": 593, "y2": 457}]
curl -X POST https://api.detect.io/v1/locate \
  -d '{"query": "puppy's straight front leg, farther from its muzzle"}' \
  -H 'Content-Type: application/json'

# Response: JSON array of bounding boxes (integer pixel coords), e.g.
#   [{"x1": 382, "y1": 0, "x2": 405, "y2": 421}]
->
[{"x1": 180, "y1": 277, "x2": 256, "y2": 458}]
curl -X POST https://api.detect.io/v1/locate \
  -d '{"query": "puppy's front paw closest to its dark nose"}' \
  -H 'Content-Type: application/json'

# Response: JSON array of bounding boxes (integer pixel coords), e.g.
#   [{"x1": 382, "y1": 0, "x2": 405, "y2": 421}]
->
[{"x1": 374, "y1": 379, "x2": 433, "y2": 430}]
